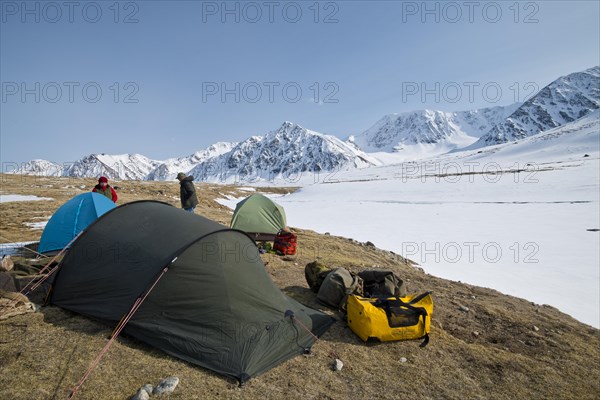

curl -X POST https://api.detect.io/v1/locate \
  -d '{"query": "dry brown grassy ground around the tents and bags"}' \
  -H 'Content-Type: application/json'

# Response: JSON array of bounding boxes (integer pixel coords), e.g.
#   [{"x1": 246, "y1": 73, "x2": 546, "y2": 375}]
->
[{"x1": 0, "y1": 175, "x2": 600, "y2": 399}]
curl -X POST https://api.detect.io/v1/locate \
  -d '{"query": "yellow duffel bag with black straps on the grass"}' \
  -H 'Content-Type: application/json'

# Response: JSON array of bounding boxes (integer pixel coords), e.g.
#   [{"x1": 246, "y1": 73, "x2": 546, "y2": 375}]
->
[{"x1": 348, "y1": 292, "x2": 433, "y2": 347}]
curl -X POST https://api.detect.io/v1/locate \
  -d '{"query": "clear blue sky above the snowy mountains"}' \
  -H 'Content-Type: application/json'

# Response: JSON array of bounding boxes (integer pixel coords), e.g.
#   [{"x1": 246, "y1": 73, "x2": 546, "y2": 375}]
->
[{"x1": 0, "y1": 0, "x2": 600, "y2": 164}]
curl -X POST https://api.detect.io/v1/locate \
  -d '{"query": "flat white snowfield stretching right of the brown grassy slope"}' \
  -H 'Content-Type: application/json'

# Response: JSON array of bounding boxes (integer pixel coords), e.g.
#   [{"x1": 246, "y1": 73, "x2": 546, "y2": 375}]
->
[{"x1": 277, "y1": 159, "x2": 600, "y2": 327}]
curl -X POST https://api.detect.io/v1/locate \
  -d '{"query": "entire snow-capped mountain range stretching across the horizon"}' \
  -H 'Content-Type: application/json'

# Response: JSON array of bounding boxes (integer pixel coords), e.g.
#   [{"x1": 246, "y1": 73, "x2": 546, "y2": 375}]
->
[{"x1": 14, "y1": 66, "x2": 600, "y2": 182}]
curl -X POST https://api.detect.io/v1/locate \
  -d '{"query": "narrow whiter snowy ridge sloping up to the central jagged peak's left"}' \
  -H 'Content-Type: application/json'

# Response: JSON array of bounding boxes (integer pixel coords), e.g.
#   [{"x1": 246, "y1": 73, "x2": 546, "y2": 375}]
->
[{"x1": 145, "y1": 142, "x2": 237, "y2": 181}]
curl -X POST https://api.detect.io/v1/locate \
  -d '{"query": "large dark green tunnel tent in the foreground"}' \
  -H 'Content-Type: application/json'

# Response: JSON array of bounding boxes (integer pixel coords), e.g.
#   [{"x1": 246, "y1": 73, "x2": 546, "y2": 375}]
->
[{"x1": 51, "y1": 201, "x2": 334, "y2": 383}]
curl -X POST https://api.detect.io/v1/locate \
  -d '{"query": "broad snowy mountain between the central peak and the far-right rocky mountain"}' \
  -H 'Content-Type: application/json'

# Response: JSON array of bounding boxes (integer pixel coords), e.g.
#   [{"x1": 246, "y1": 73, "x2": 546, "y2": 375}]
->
[{"x1": 348, "y1": 103, "x2": 520, "y2": 152}]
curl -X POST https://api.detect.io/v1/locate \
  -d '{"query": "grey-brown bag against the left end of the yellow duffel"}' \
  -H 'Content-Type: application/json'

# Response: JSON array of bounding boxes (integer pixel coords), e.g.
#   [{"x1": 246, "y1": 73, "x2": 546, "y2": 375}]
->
[{"x1": 317, "y1": 268, "x2": 362, "y2": 310}]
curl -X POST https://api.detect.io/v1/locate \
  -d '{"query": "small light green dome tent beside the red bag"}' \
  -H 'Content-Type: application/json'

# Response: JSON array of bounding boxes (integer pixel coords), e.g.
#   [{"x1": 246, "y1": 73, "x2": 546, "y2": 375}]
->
[{"x1": 231, "y1": 193, "x2": 287, "y2": 235}]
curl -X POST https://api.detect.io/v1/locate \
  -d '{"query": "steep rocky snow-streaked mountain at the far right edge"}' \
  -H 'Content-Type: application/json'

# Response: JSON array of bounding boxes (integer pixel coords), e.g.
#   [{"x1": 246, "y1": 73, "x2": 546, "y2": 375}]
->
[{"x1": 469, "y1": 66, "x2": 600, "y2": 149}]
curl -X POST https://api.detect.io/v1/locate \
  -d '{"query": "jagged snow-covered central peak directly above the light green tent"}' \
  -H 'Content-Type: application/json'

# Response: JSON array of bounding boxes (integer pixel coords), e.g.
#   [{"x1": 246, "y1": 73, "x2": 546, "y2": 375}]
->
[{"x1": 190, "y1": 121, "x2": 380, "y2": 181}]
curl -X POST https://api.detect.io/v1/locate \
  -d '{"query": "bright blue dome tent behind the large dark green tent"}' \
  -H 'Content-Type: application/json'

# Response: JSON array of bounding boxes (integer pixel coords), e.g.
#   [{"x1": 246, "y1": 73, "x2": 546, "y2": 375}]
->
[{"x1": 38, "y1": 192, "x2": 116, "y2": 253}]
